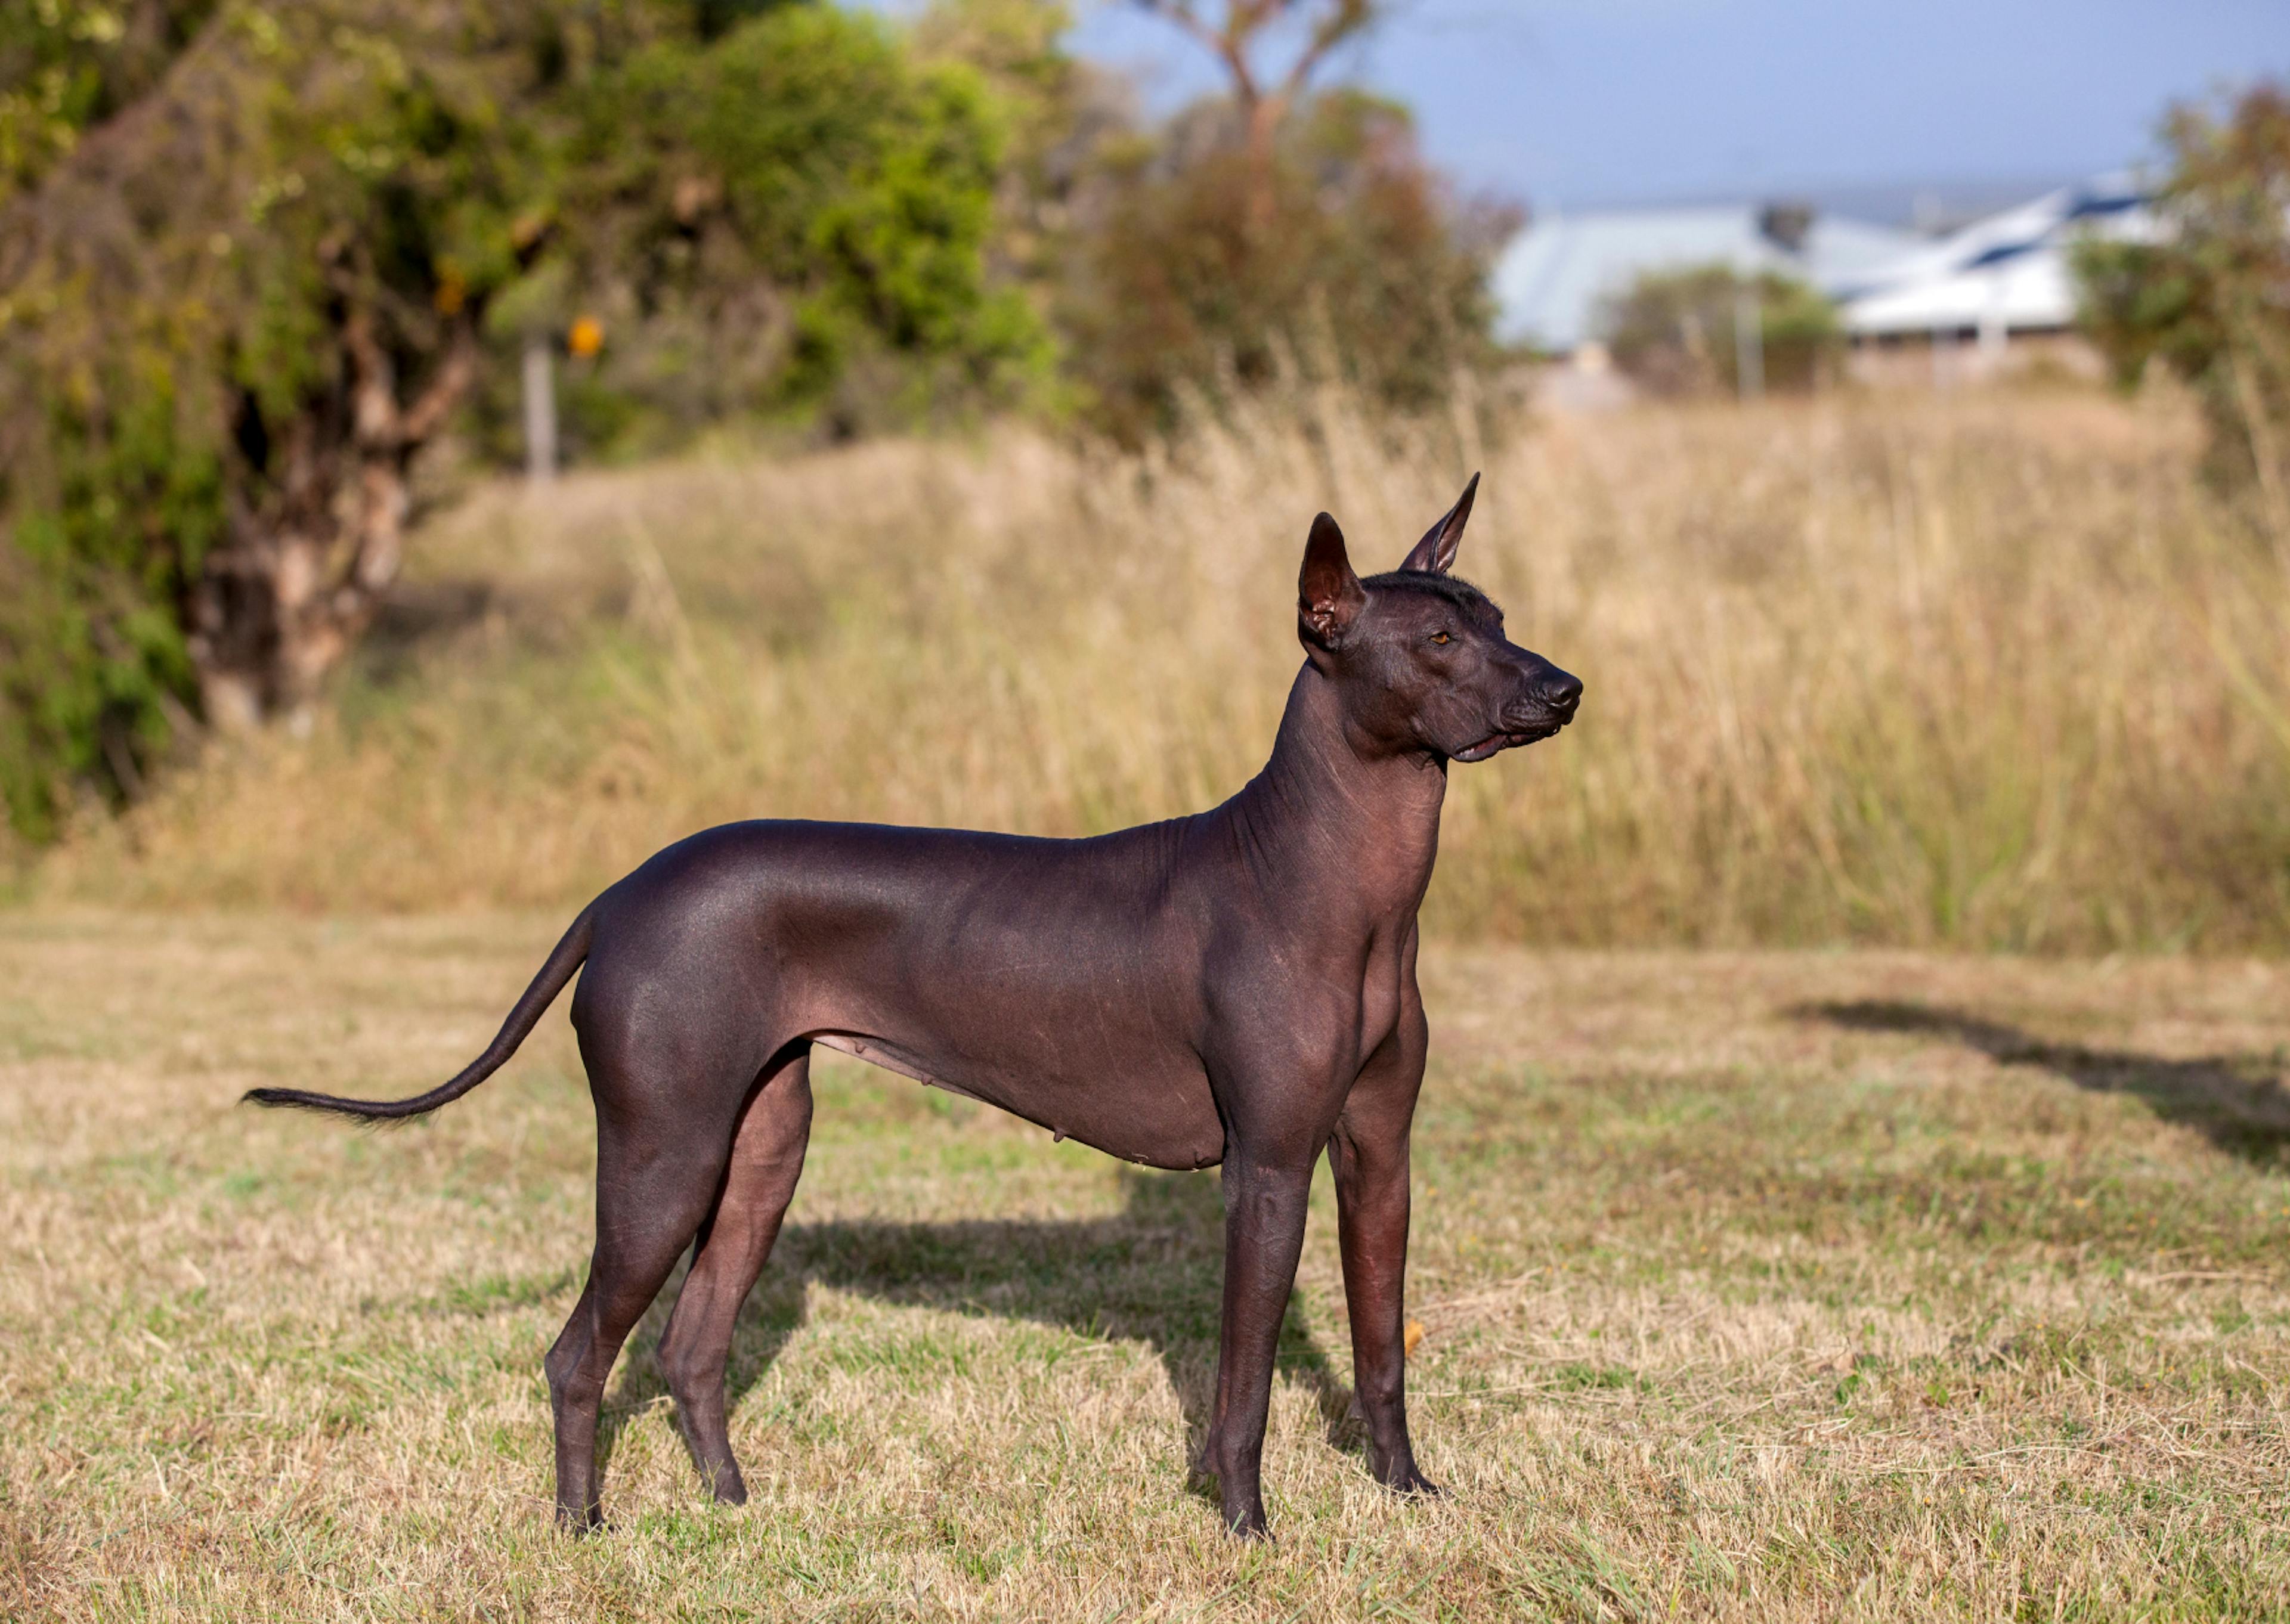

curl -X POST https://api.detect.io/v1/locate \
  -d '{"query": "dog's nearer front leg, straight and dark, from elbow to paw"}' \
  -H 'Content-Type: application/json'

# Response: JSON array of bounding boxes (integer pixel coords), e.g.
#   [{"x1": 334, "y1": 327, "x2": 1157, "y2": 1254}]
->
[{"x1": 1202, "y1": 1148, "x2": 1312, "y2": 1539}]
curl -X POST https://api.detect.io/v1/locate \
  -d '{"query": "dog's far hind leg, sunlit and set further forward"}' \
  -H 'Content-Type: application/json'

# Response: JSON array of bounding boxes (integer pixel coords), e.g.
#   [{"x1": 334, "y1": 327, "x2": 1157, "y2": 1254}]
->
[{"x1": 660, "y1": 1045, "x2": 810, "y2": 1505}]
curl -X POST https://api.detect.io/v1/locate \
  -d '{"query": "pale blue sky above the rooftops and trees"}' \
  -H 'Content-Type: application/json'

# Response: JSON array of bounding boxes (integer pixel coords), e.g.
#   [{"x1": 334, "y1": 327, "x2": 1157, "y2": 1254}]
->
[{"x1": 1053, "y1": 0, "x2": 2290, "y2": 209}]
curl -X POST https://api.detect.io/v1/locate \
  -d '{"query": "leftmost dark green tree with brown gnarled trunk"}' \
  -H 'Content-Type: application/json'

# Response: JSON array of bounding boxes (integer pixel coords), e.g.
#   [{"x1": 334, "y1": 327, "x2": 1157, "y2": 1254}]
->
[{"x1": 0, "y1": 2, "x2": 545, "y2": 811}]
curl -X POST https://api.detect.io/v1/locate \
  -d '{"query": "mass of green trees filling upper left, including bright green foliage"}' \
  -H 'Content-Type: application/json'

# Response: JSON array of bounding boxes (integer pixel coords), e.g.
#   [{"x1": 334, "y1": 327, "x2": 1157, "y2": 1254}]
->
[{"x1": 0, "y1": 0, "x2": 1047, "y2": 838}]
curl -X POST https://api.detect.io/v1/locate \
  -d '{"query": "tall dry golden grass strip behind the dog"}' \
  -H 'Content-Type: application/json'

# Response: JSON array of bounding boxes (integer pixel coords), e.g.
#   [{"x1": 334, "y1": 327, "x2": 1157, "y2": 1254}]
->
[{"x1": 36, "y1": 382, "x2": 2290, "y2": 950}]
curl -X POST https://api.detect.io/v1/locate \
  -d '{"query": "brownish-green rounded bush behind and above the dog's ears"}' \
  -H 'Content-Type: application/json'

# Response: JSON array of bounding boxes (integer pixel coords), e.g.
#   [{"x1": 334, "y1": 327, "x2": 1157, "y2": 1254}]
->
[{"x1": 1060, "y1": 89, "x2": 1514, "y2": 440}]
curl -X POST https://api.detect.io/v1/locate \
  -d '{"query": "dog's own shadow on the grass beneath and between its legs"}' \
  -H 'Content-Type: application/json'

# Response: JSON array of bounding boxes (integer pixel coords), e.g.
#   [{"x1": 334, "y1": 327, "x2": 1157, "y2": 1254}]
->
[{"x1": 598, "y1": 1168, "x2": 1365, "y2": 1493}]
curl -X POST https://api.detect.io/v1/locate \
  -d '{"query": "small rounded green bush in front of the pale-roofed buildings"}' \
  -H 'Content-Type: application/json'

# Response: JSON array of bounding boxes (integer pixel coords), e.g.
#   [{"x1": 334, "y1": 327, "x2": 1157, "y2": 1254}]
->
[{"x1": 1598, "y1": 264, "x2": 1843, "y2": 394}]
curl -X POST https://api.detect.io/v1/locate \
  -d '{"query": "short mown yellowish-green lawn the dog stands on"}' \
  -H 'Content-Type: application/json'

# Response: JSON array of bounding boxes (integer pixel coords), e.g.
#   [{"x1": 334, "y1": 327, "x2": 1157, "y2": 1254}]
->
[{"x1": 0, "y1": 909, "x2": 2290, "y2": 1619}]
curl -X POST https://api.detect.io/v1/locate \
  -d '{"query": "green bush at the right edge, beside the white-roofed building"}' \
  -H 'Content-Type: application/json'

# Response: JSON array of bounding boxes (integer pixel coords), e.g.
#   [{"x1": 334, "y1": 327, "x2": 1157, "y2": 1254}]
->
[{"x1": 2075, "y1": 85, "x2": 2290, "y2": 513}]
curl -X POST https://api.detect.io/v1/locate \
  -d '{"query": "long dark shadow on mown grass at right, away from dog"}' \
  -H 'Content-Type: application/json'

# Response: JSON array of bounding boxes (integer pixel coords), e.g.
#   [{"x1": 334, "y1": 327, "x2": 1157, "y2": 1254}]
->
[{"x1": 1791, "y1": 1001, "x2": 2290, "y2": 1168}]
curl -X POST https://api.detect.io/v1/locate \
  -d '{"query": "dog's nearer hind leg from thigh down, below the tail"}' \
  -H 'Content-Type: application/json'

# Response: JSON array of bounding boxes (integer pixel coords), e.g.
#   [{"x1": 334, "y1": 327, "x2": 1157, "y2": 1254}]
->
[{"x1": 545, "y1": 1045, "x2": 739, "y2": 1530}]
